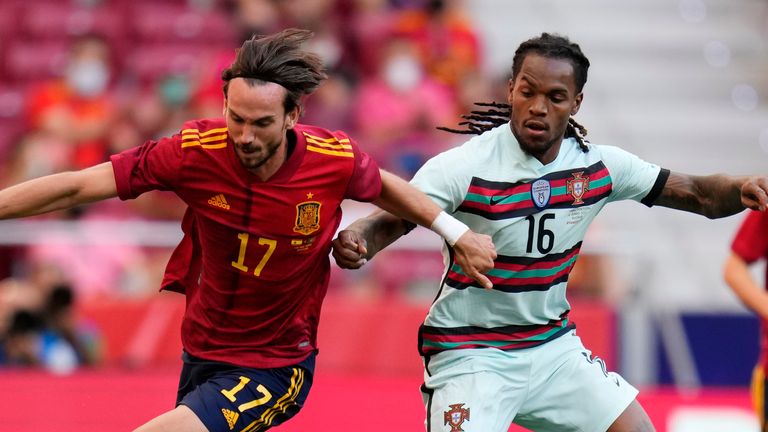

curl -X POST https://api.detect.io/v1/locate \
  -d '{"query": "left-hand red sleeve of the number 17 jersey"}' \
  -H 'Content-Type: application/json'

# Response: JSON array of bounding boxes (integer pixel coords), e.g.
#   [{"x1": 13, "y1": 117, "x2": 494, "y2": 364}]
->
[{"x1": 110, "y1": 135, "x2": 181, "y2": 200}]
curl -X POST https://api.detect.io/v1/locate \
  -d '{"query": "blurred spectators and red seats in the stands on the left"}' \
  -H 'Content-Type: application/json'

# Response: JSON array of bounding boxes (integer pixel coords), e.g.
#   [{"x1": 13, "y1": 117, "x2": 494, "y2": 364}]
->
[{"x1": 0, "y1": 0, "x2": 503, "y2": 367}]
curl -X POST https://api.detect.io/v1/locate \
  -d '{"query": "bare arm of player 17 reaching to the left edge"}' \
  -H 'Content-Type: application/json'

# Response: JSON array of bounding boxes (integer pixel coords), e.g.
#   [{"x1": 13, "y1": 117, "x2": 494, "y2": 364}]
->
[{"x1": 0, "y1": 162, "x2": 117, "y2": 219}]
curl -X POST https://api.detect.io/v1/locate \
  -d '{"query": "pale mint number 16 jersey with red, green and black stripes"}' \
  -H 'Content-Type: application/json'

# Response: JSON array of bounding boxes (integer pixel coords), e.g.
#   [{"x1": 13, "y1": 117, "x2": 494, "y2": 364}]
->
[{"x1": 411, "y1": 124, "x2": 669, "y2": 355}]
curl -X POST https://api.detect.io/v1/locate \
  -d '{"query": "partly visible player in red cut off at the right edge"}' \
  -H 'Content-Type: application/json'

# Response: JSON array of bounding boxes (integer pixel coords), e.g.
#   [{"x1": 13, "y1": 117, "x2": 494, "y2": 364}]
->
[{"x1": 723, "y1": 211, "x2": 768, "y2": 431}]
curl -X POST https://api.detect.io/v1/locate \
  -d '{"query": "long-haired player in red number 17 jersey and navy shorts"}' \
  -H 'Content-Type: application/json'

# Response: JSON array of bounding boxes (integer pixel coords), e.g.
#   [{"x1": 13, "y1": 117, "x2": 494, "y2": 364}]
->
[{"x1": 0, "y1": 29, "x2": 496, "y2": 431}]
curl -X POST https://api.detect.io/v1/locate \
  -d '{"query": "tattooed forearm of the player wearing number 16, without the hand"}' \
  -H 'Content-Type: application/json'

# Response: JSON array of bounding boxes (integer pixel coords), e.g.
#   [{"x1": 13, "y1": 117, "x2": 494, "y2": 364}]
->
[{"x1": 654, "y1": 173, "x2": 748, "y2": 219}]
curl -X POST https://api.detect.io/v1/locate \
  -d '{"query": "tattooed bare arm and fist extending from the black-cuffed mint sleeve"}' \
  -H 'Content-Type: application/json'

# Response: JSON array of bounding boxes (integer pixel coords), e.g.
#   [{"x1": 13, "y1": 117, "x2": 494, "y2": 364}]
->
[{"x1": 654, "y1": 172, "x2": 768, "y2": 219}]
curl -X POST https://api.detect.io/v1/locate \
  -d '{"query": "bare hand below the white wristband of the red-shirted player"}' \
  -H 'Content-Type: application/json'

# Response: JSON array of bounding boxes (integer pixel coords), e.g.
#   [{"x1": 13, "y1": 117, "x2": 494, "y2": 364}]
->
[{"x1": 453, "y1": 230, "x2": 496, "y2": 289}]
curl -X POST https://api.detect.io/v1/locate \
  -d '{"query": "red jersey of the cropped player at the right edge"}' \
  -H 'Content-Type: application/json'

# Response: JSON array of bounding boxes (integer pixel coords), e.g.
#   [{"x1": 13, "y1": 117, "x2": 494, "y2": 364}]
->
[{"x1": 731, "y1": 211, "x2": 768, "y2": 370}]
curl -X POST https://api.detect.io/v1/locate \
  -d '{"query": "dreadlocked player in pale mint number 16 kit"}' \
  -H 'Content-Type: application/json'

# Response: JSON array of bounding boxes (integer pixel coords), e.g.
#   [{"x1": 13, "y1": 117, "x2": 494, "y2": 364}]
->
[{"x1": 333, "y1": 33, "x2": 768, "y2": 432}]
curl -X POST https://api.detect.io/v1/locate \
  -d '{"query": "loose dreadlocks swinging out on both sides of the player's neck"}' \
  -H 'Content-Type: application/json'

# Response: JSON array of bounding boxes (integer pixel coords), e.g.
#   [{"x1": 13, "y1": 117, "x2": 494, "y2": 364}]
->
[{"x1": 437, "y1": 102, "x2": 589, "y2": 153}]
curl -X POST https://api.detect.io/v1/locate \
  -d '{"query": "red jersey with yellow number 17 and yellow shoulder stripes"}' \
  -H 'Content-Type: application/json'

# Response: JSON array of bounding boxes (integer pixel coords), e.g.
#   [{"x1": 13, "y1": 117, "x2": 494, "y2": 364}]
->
[{"x1": 111, "y1": 120, "x2": 381, "y2": 368}]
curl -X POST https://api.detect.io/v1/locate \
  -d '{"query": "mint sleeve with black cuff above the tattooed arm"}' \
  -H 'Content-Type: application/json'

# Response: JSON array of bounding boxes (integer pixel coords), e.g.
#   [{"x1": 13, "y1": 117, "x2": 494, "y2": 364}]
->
[{"x1": 594, "y1": 146, "x2": 668, "y2": 205}]
